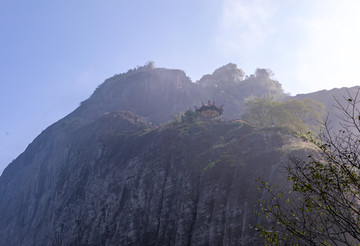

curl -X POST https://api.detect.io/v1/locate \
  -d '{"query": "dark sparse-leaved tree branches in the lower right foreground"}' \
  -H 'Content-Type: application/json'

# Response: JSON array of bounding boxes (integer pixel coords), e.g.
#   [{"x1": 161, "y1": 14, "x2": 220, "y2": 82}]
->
[{"x1": 256, "y1": 91, "x2": 360, "y2": 245}]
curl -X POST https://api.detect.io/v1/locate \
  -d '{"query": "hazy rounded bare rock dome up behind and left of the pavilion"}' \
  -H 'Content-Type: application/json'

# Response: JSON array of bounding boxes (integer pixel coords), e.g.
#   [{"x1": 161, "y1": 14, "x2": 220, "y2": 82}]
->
[{"x1": 69, "y1": 68, "x2": 197, "y2": 124}]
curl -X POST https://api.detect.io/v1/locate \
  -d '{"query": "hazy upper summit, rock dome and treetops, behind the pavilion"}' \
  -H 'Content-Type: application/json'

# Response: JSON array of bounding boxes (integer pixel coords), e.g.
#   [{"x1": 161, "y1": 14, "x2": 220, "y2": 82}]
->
[{"x1": 67, "y1": 63, "x2": 283, "y2": 124}]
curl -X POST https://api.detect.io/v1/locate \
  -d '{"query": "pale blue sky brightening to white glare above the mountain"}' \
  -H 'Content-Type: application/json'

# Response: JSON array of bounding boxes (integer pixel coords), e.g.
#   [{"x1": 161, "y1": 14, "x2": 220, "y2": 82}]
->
[{"x1": 0, "y1": 0, "x2": 360, "y2": 173}]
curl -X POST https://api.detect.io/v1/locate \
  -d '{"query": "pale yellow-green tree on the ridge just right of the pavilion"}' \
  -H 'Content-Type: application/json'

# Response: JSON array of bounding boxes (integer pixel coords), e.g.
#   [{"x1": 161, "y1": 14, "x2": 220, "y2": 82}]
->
[{"x1": 242, "y1": 98, "x2": 324, "y2": 134}]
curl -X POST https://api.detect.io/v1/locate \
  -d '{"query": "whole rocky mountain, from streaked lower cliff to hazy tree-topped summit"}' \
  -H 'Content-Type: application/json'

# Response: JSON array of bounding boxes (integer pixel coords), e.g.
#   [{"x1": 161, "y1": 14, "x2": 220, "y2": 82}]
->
[{"x1": 0, "y1": 63, "x2": 344, "y2": 246}]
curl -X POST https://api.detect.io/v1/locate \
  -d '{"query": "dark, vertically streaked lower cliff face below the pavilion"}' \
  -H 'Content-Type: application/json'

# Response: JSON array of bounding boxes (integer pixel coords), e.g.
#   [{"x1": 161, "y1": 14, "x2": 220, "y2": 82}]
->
[{"x1": 0, "y1": 113, "x2": 306, "y2": 245}]
